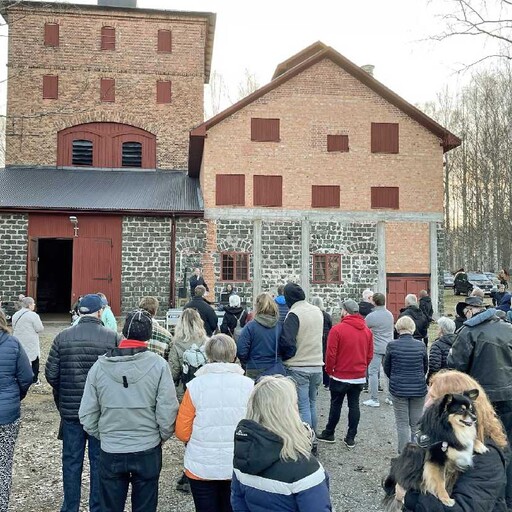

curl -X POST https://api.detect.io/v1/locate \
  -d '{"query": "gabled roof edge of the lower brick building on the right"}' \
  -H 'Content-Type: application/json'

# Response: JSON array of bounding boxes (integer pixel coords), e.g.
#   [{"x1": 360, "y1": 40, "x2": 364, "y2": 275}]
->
[{"x1": 188, "y1": 41, "x2": 461, "y2": 177}]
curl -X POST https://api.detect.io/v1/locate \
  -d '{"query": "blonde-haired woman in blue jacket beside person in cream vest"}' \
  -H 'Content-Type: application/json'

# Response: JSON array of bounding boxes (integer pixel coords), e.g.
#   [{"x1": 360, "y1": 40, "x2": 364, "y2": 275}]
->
[{"x1": 236, "y1": 293, "x2": 285, "y2": 380}]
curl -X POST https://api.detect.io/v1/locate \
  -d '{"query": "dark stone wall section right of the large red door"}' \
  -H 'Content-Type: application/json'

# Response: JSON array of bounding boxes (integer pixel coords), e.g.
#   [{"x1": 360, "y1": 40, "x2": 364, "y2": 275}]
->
[{"x1": 121, "y1": 217, "x2": 171, "y2": 314}]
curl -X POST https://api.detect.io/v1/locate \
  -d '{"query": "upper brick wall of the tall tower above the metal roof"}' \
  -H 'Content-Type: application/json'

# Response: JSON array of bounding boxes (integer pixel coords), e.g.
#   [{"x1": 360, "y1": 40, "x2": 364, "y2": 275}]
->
[{"x1": 6, "y1": 4, "x2": 207, "y2": 169}]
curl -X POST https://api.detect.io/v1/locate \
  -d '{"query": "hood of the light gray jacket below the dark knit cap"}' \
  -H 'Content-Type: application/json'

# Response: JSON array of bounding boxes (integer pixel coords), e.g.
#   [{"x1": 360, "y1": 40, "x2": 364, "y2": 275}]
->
[{"x1": 98, "y1": 348, "x2": 160, "y2": 384}]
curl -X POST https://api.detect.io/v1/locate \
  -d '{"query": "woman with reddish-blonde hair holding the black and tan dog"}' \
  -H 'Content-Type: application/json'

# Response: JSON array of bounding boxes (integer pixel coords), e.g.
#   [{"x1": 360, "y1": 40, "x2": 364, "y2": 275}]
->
[{"x1": 397, "y1": 370, "x2": 508, "y2": 512}]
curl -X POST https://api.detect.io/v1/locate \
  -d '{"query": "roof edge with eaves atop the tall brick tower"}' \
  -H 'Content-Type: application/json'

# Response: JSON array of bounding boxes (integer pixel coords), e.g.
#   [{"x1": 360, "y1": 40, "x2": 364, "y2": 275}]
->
[{"x1": 0, "y1": 0, "x2": 216, "y2": 83}]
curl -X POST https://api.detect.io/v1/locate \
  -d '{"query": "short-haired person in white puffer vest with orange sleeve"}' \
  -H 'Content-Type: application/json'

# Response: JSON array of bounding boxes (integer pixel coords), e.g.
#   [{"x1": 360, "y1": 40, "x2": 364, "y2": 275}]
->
[{"x1": 176, "y1": 334, "x2": 254, "y2": 512}]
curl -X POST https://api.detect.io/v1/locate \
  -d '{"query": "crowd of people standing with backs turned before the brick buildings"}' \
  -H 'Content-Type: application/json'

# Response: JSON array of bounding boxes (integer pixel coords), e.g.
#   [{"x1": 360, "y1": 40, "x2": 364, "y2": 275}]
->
[{"x1": 0, "y1": 271, "x2": 512, "y2": 512}]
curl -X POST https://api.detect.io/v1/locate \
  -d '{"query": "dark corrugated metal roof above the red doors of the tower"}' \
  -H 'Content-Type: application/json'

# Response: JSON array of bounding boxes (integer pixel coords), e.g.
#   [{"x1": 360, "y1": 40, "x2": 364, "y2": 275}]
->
[{"x1": 0, "y1": 167, "x2": 203, "y2": 213}]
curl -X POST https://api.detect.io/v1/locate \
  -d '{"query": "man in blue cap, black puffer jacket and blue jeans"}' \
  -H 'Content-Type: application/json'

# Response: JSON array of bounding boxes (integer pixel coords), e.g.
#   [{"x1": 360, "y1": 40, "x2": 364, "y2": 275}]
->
[{"x1": 45, "y1": 294, "x2": 119, "y2": 512}]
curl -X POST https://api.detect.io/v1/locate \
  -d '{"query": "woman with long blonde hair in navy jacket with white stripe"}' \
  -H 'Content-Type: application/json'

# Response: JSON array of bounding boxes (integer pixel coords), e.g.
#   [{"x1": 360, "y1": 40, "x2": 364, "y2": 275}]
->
[{"x1": 231, "y1": 376, "x2": 332, "y2": 512}]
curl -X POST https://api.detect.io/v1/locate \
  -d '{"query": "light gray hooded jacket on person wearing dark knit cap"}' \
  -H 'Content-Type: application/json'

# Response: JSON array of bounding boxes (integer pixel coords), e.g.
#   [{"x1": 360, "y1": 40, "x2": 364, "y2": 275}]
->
[{"x1": 78, "y1": 349, "x2": 178, "y2": 453}]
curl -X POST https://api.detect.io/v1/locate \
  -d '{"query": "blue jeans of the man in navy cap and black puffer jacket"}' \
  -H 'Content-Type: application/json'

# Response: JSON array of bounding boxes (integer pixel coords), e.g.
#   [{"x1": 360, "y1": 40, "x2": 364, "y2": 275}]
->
[{"x1": 60, "y1": 420, "x2": 101, "y2": 512}]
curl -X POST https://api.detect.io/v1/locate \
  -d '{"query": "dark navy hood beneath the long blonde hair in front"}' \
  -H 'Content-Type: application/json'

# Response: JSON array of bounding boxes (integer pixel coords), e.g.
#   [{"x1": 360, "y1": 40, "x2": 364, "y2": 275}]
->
[{"x1": 234, "y1": 420, "x2": 283, "y2": 475}]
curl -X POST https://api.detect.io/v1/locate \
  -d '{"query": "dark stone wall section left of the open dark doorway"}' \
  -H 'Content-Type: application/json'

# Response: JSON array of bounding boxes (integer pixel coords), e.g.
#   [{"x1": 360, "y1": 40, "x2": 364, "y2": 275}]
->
[{"x1": 0, "y1": 213, "x2": 28, "y2": 300}]
